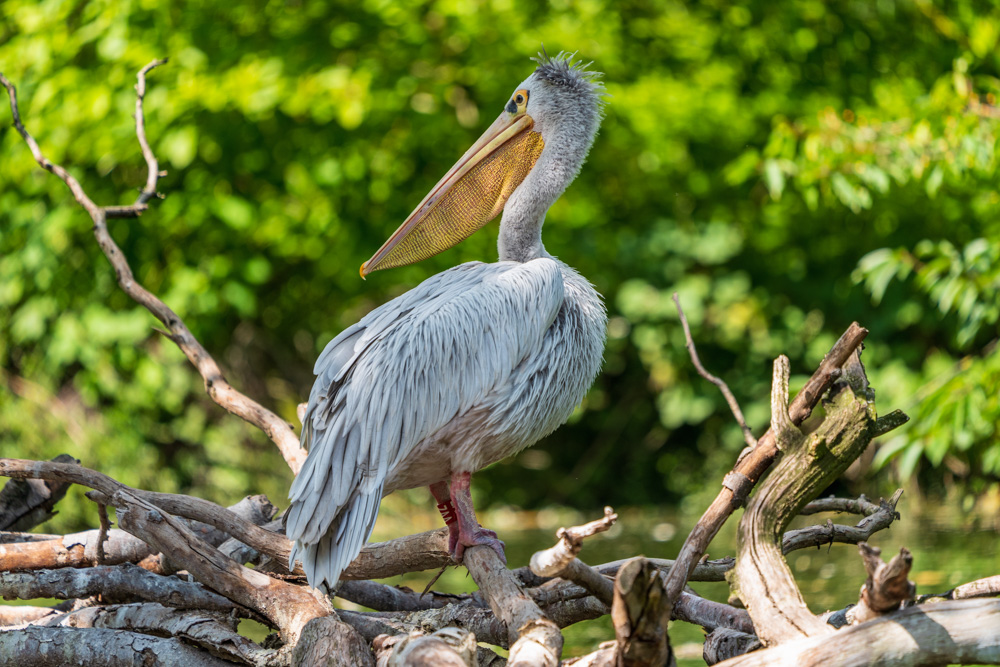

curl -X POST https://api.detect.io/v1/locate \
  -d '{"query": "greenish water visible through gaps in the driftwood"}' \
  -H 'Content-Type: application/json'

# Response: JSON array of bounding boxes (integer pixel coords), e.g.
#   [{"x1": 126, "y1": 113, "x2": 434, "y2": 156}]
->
[{"x1": 368, "y1": 494, "x2": 1000, "y2": 665}]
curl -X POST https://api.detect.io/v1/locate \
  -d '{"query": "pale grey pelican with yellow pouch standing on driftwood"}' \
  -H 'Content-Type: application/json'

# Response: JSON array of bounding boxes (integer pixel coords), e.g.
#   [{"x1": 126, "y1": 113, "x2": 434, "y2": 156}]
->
[{"x1": 286, "y1": 53, "x2": 607, "y2": 591}]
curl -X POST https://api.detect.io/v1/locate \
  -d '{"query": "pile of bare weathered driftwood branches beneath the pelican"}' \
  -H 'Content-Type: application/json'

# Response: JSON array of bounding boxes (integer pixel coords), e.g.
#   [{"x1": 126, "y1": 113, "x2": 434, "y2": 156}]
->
[{"x1": 0, "y1": 61, "x2": 1000, "y2": 667}]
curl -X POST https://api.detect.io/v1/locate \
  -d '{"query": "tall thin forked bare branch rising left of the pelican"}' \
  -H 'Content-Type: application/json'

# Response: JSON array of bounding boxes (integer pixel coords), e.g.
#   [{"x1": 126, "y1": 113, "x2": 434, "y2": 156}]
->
[{"x1": 0, "y1": 64, "x2": 306, "y2": 474}]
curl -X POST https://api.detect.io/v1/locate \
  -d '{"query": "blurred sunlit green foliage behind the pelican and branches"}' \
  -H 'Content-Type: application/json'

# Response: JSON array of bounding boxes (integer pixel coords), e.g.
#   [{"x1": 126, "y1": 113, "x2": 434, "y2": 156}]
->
[{"x1": 0, "y1": 0, "x2": 1000, "y2": 530}]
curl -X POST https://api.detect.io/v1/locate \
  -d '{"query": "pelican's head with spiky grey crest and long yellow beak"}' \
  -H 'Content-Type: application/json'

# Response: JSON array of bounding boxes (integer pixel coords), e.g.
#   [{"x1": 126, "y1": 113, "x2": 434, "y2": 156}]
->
[{"x1": 361, "y1": 53, "x2": 604, "y2": 278}]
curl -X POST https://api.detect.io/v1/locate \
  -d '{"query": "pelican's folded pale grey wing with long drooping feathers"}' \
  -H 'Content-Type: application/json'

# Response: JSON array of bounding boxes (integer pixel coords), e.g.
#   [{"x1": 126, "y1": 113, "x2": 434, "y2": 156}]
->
[{"x1": 286, "y1": 258, "x2": 563, "y2": 586}]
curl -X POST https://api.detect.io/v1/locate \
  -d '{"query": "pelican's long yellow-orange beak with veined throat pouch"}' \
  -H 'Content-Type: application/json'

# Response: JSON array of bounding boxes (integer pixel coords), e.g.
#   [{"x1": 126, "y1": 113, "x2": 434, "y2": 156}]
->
[{"x1": 361, "y1": 112, "x2": 545, "y2": 278}]
